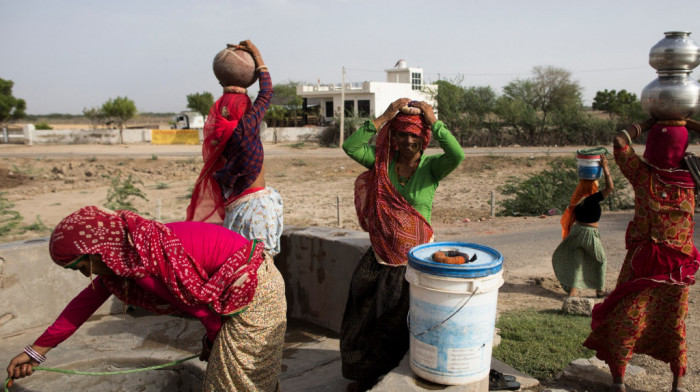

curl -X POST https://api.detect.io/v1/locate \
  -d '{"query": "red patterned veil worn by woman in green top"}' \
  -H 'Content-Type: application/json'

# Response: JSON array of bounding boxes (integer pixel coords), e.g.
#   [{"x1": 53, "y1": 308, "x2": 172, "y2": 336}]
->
[{"x1": 355, "y1": 113, "x2": 433, "y2": 265}]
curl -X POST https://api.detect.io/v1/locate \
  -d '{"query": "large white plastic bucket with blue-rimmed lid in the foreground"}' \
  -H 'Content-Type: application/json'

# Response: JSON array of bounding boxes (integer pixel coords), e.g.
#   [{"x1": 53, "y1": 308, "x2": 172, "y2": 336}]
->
[{"x1": 406, "y1": 242, "x2": 503, "y2": 392}]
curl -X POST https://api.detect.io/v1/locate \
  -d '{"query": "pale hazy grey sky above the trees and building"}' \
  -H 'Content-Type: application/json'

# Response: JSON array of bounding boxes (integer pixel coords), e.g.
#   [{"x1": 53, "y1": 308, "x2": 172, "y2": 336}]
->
[{"x1": 0, "y1": 0, "x2": 700, "y2": 114}]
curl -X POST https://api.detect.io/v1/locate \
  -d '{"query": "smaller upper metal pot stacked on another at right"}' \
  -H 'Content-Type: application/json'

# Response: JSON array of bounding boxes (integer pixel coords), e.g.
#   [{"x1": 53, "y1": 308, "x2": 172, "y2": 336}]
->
[{"x1": 649, "y1": 31, "x2": 700, "y2": 71}]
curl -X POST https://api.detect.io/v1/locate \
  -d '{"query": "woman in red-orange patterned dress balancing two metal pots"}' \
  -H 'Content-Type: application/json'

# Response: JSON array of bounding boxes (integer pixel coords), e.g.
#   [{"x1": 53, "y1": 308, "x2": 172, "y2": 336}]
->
[{"x1": 584, "y1": 119, "x2": 700, "y2": 392}]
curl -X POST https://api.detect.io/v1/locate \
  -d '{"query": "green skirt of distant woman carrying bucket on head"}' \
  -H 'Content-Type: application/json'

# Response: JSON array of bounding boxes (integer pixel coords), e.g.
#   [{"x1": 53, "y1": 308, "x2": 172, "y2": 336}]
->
[{"x1": 552, "y1": 225, "x2": 607, "y2": 292}]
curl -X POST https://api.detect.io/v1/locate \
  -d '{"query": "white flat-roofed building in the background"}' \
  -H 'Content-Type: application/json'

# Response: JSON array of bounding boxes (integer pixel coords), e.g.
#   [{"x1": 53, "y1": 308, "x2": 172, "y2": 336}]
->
[{"x1": 297, "y1": 60, "x2": 437, "y2": 120}]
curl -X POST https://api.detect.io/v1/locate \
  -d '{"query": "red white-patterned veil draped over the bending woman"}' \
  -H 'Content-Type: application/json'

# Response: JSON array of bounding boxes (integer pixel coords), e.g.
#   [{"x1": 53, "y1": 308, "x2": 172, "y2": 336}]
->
[{"x1": 49, "y1": 206, "x2": 263, "y2": 315}]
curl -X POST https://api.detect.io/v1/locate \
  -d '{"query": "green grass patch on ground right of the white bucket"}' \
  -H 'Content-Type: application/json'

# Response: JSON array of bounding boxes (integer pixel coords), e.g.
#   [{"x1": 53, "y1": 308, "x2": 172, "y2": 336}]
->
[{"x1": 493, "y1": 310, "x2": 594, "y2": 380}]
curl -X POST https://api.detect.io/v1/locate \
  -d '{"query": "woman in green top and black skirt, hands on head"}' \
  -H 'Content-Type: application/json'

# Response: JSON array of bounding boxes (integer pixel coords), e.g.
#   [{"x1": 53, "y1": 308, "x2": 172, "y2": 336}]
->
[{"x1": 340, "y1": 98, "x2": 464, "y2": 391}]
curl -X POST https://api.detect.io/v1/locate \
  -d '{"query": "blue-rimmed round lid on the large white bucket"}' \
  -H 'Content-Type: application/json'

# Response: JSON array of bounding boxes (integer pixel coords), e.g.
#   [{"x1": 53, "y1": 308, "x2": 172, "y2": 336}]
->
[{"x1": 408, "y1": 242, "x2": 503, "y2": 278}]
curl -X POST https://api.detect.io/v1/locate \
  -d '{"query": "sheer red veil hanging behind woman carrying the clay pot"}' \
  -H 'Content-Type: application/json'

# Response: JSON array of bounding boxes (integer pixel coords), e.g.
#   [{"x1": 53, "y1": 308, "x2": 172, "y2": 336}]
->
[{"x1": 186, "y1": 93, "x2": 252, "y2": 224}]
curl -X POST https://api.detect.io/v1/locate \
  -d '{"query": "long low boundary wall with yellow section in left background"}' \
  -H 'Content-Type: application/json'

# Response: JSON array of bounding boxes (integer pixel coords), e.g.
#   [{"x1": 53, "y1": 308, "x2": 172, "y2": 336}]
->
[{"x1": 0, "y1": 123, "x2": 326, "y2": 145}]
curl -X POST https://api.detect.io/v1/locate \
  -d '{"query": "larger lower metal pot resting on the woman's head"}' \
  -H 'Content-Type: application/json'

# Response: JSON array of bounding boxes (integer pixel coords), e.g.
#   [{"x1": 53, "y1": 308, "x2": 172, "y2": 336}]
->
[{"x1": 641, "y1": 71, "x2": 700, "y2": 120}]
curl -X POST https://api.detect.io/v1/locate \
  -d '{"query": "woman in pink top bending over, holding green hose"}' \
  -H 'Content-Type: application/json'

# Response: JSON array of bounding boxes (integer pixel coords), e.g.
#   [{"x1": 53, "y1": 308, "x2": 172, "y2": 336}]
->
[{"x1": 7, "y1": 206, "x2": 286, "y2": 391}]
